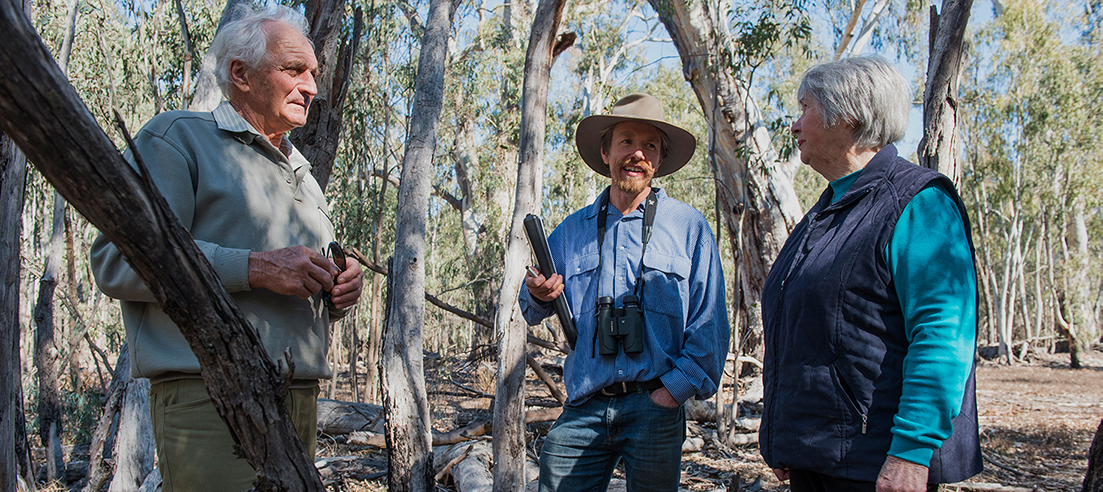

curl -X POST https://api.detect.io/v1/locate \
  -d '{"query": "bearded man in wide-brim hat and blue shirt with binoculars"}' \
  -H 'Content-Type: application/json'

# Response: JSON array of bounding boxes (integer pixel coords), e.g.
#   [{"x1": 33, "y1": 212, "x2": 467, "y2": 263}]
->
[{"x1": 518, "y1": 94, "x2": 729, "y2": 492}]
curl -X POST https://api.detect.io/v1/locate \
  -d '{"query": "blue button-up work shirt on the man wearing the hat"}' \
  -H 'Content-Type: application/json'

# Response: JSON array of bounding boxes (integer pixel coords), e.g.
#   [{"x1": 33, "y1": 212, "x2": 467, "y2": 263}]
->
[{"x1": 518, "y1": 189, "x2": 730, "y2": 405}]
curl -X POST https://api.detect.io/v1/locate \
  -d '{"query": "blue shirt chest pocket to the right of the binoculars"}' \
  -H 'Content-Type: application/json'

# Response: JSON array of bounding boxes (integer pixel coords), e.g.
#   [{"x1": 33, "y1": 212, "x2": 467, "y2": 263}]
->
[{"x1": 641, "y1": 252, "x2": 693, "y2": 320}]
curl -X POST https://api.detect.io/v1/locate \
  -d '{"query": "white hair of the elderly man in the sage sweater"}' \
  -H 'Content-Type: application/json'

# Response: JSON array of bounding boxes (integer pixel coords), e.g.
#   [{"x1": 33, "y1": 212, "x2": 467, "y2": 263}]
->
[{"x1": 211, "y1": 4, "x2": 314, "y2": 99}]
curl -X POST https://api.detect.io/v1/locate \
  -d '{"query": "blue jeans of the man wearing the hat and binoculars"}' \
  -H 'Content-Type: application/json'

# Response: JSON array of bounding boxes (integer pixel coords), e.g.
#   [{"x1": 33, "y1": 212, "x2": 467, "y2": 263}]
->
[{"x1": 539, "y1": 392, "x2": 686, "y2": 492}]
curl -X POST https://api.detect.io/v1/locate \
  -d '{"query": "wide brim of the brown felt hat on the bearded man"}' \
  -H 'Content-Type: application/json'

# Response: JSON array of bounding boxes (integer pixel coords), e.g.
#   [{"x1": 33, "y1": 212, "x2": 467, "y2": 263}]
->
[{"x1": 575, "y1": 115, "x2": 697, "y2": 178}]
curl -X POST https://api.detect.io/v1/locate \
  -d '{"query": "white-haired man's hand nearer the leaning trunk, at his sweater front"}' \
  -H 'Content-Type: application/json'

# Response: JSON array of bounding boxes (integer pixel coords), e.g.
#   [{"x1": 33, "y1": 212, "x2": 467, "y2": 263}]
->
[{"x1": 249, "y1": 246, "x2": 335, "y2": 299}]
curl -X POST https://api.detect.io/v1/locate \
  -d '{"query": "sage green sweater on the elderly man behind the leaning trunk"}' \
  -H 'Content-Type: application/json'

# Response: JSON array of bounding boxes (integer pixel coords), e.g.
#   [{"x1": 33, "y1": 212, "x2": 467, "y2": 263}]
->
[{"x1": 92, "y1": 103, "x2": 344, "y2": 386}]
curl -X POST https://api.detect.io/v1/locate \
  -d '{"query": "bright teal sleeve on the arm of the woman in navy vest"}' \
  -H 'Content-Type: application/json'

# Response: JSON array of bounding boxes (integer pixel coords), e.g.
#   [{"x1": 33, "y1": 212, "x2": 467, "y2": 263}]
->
[{"x1": 885, "y1": 182, "x2": 976, "y2": 466}]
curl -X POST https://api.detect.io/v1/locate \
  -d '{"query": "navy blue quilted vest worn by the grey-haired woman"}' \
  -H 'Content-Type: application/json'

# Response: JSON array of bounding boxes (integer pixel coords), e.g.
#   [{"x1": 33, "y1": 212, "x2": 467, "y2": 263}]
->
[{"x1": 759, "y1": 145, "x2": 982, "y2": 483}]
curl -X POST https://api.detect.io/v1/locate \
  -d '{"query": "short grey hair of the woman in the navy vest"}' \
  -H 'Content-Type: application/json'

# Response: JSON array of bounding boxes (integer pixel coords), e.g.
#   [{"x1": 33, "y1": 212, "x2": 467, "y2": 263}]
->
[{"x1": 796, "y1": 55, "x2": 911, "y2": 149}]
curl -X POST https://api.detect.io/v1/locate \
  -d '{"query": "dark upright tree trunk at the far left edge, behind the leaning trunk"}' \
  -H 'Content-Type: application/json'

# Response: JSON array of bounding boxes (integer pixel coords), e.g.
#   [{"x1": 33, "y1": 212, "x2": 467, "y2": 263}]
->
[{"x1": 0, "y1": 129, "x2": 26, "y2": 491}]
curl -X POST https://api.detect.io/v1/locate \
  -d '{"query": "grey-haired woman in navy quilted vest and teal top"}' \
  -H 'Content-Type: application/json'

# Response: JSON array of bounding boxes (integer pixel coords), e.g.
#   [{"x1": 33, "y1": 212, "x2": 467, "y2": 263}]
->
[{"x1": 759, "y1": 56, "x2": 982, "y2": 492}]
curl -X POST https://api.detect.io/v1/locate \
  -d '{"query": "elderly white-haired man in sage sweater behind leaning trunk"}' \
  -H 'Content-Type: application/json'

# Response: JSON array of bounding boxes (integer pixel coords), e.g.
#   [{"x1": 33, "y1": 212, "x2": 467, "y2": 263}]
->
[{"x1": 92, "y1": 8, "x2": 363, "y2": 492}]
